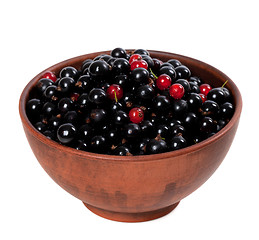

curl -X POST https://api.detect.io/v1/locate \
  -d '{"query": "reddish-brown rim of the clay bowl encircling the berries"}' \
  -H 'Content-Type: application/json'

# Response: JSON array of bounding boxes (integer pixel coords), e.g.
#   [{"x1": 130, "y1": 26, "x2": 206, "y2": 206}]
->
[{"x1": 19, "y1": 49, "x2": 242, "y2": 162}]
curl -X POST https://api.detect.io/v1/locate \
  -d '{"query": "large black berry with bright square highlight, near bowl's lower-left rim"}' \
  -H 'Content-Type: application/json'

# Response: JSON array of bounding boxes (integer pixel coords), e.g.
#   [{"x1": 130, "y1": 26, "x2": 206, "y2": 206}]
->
[{"x1": 57, "y1": 123, "x2": 76, "y2": 144}]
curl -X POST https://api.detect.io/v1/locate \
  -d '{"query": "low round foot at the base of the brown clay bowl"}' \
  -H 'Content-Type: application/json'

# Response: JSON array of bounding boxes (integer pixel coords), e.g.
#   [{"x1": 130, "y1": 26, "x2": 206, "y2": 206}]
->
[{"x1": 84, "y1": 202, "x2": 179, "y2": 222}]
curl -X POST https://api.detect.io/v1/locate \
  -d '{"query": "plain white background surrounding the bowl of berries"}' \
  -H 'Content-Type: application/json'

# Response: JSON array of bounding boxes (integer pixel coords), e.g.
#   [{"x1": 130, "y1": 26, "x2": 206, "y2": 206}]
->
[{"x1": 0, "y1": 0, "x2": 259, "y2": 240}]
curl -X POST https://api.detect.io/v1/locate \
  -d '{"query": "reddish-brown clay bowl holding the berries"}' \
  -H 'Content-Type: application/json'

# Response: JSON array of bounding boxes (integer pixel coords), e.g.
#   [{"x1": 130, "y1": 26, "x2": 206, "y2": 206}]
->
[{"x1": 19, "y1": 50, "x2": 242, "y2": 222}]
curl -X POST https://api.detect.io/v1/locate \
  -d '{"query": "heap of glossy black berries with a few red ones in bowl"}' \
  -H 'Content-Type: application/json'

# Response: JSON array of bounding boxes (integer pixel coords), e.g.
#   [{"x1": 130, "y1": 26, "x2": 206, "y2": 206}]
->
[{"x1": 26, "y1": 48, "x2": 234, "y2": 156}]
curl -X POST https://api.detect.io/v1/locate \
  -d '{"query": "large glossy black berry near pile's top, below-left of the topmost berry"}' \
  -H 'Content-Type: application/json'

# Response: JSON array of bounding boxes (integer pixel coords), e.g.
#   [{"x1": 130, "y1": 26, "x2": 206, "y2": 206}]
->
[{"x1": 89, "y1": 60, "x2": 110, "y2": 80}]
